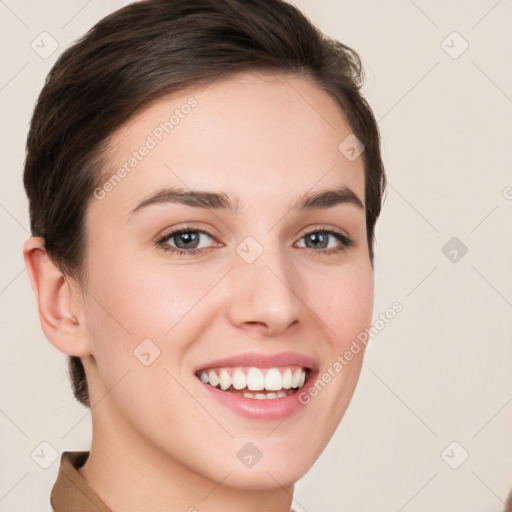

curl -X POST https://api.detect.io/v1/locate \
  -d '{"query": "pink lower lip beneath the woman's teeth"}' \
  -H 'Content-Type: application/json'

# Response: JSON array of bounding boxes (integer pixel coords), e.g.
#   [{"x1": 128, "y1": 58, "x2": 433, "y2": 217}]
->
[{"x1": 197, "y1": 371, "x2": 316, "y2": 420}]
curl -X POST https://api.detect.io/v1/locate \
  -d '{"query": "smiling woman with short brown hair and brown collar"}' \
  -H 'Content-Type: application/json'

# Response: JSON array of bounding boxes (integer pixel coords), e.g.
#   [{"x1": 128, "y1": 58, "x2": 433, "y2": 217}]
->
[{"x1": 24, "y1": 0, "x2": 385, "y2": 512}]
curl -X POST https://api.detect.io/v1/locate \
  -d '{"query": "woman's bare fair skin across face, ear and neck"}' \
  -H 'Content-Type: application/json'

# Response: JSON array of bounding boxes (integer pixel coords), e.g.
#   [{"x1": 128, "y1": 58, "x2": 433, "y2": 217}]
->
[{"x1": 24, "y1": 73, "x2": 373, "y2": 512}]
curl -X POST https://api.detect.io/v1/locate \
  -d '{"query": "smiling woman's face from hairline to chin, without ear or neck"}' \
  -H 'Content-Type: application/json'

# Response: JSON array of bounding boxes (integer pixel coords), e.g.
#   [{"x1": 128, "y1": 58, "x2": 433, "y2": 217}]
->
[{"x1": 84, "y1": 74, "x2": 373, "y2": 489}]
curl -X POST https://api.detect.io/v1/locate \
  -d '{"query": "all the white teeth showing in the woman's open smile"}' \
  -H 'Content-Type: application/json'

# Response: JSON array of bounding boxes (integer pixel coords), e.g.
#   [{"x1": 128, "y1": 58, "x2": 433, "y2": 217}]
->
[{"x1": 198, "y1": 367, "x2": 306, "y2": 400}]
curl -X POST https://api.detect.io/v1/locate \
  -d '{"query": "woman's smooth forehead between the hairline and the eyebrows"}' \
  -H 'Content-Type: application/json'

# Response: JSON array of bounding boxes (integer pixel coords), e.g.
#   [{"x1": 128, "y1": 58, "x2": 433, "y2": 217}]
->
[{"x1": 92, "y1": 73, "x2": 364, "y2": 214}]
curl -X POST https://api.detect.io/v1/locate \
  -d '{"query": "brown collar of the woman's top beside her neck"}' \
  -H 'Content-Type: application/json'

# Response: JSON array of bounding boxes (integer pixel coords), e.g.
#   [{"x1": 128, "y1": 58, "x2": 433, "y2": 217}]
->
[{"x1": 50, "y1": 452, "x2": 112, "y2": 512}]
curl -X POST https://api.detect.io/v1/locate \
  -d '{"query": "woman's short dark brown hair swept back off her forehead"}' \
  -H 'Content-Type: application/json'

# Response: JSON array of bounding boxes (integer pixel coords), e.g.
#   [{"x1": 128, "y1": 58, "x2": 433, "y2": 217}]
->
[{"x1": 24, "y1": 0, "x2": 386, "y2": 406}]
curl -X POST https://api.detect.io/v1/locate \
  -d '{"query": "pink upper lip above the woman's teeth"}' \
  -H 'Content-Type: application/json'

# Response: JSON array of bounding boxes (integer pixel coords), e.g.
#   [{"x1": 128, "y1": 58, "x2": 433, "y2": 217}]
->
[{"x1": 194, "y1": 352, "x2": 318, "y2": 372}]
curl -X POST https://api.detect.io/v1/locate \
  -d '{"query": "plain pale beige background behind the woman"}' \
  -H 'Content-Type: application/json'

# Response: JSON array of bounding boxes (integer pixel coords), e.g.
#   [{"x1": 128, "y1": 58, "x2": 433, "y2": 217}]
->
[{"x1": 0, "y1": 0, "x2": 512, "y2": 512}]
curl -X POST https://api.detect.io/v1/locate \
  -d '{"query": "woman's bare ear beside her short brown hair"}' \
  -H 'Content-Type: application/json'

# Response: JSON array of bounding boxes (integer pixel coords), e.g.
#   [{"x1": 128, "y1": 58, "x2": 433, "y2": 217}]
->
[{"x1": 23, "y1": 236, "x2": 91, "y2": 357}]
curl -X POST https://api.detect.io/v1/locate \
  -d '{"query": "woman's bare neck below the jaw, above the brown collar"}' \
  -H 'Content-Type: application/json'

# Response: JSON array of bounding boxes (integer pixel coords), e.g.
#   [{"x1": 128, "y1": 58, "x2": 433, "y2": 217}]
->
[{"x1": 79, "y1": 400, "x2": 293, "y2": 512}]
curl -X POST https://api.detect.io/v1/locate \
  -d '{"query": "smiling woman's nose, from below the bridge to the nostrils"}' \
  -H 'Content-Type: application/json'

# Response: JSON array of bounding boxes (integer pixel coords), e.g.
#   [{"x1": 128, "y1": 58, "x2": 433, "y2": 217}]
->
[{"x1": 228, "y1": 244, "x2": 304, "y2": 336}]
